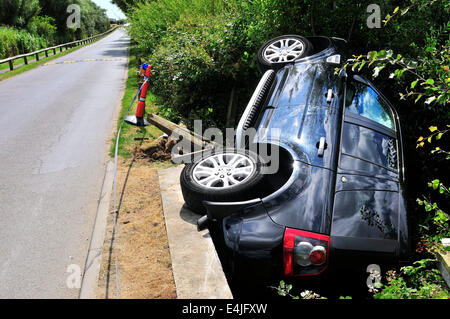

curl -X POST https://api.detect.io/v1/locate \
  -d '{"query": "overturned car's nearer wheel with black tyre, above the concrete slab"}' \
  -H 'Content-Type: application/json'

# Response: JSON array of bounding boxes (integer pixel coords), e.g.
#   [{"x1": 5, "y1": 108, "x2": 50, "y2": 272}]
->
[{"x1": 180, "y1": 149, "x2": 264, "y2": 214}]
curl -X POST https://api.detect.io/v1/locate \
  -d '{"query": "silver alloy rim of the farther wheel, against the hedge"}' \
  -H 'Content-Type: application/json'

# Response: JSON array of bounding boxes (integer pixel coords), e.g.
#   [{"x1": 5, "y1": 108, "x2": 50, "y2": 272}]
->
[{"x1": 263, "y1": 38, "x2": 305, "y2": 63}]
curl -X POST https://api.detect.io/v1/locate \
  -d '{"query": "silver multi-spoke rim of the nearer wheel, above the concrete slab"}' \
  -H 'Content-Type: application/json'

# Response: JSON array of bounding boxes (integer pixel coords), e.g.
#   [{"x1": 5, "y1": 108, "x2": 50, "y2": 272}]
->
[{"x1": 192, "y1": 153, "x2": 256, "y2": 189}]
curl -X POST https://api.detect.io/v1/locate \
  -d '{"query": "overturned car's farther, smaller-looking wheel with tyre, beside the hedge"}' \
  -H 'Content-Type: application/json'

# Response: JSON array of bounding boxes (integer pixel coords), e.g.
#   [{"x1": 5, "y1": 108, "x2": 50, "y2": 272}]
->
[{"x1": 258, "y1": 35, "x2": 313, "y2": 72}]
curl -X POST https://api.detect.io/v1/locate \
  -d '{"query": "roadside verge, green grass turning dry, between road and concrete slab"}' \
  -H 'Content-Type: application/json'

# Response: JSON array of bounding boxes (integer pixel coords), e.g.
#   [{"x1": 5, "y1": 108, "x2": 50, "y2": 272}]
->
[{"x1": 97, "y1": 48, "x2": 176, "y2": 299}]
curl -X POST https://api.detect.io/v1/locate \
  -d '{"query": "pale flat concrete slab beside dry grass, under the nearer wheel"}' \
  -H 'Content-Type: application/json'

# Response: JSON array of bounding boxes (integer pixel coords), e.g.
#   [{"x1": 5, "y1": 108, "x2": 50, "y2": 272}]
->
[{"x1": 158, "y1": 165, "x2": 233, "y2": 299}]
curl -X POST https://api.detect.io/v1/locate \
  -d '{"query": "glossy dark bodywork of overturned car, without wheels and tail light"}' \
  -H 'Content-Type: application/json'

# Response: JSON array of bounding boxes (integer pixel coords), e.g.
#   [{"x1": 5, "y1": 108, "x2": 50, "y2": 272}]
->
[{"x1": 205, "y1": 38, "x2": 408, "y2": 277}]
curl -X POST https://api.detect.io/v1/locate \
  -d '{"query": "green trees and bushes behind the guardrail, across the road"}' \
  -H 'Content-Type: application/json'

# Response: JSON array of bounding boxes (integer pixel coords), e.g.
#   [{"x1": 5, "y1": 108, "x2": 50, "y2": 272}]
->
[{"x1": 0, "y1": 0, "x2": 109, "y2": 58}]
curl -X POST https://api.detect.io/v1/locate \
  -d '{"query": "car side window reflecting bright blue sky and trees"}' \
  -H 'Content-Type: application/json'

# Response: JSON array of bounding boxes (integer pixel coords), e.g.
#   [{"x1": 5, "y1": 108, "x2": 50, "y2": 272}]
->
[{"x1": 345, "y1": 82, "x2": 395, "y2": 130}]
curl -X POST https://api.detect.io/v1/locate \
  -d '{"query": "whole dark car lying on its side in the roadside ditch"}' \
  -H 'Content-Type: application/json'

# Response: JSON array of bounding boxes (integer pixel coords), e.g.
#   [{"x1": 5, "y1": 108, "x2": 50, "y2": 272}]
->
[{"x1": 181, "y1": 35, "x2": 409, "y2": 296}]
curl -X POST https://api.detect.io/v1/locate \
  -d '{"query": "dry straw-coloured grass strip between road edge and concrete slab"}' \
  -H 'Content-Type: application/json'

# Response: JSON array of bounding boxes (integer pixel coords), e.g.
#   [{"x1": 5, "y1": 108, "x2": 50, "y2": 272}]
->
[{"x1": 98, "y1": 160, "x2": 176, "y2": 299}]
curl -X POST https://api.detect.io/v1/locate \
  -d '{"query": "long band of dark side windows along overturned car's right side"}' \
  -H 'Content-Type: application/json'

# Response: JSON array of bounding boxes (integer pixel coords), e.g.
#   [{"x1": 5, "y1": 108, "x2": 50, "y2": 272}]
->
[{"x1": 331, "y1": 76, "x2": 401, "y2": 264}]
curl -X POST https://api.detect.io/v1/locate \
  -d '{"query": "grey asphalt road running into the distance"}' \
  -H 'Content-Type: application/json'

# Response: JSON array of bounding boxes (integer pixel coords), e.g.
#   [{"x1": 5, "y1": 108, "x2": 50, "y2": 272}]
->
[{"x1": 0, "y1": 30, "x2": 129, "y2": 298}]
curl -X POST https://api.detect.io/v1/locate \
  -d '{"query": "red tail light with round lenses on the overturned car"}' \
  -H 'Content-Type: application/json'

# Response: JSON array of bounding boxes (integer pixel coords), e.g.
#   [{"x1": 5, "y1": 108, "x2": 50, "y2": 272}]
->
[{"x1": 283, "y1": 228, "x2": 330, "y2": 276}]
